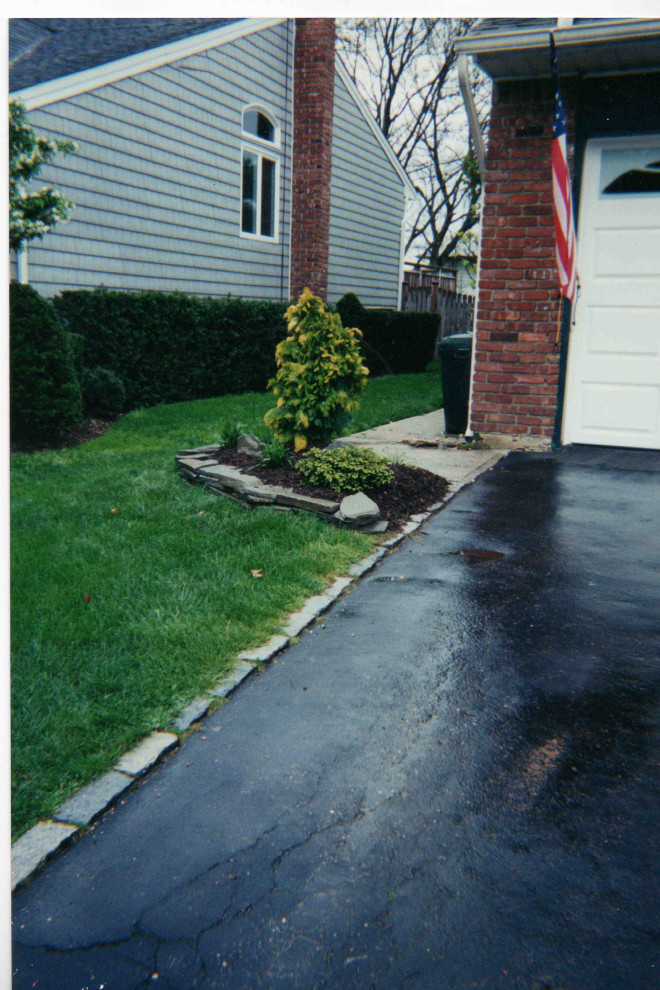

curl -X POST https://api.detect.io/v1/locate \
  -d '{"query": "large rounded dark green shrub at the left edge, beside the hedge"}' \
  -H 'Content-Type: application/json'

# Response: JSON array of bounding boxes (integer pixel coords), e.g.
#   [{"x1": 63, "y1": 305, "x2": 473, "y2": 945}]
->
[{"x1": 9, "y1": 282, "x2": 82, "y2": 444}]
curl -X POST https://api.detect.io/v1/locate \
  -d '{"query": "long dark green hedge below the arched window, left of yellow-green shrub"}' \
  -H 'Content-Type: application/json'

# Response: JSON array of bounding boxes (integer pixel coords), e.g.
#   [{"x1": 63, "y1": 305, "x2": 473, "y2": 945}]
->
[{"x1": 53, "y1": 289, "x2": 286, "y2": 410}]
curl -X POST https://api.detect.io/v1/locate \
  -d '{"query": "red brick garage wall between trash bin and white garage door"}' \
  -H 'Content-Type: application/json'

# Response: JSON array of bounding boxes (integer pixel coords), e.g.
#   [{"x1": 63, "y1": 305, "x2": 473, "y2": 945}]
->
[{"x1": 471, "y1": 81, "x2": 574, "y2": 437}]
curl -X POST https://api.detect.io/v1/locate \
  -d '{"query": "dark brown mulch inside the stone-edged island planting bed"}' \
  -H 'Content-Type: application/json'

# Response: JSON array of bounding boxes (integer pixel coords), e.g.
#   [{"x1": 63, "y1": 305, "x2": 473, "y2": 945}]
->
[{"x1": 214, "y1": 447, "x2": 447, "y2": 530}]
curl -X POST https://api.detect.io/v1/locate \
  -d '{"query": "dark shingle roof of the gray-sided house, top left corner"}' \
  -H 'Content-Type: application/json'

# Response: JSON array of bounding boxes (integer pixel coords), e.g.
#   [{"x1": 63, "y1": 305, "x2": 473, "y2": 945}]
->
[{"x1": 9, "y1": 17, "x2": 241, "y2": 92}]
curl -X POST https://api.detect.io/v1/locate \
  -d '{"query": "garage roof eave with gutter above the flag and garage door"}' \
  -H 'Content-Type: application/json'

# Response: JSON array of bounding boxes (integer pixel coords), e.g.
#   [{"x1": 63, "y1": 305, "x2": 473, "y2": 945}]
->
[{"x1": 456, "y1": 17, "x2": 660, "y2": 80}]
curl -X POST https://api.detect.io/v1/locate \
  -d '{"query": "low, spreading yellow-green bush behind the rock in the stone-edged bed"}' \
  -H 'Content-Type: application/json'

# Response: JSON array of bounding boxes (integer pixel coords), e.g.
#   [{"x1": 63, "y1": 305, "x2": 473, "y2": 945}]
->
[{"x1": 299, "y1": 445, "x2": 394, "y2": 492}]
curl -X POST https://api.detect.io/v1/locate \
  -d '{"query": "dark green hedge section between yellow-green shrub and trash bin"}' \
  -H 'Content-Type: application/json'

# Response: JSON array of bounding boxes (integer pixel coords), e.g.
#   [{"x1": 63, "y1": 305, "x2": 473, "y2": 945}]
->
[{"x1": 337, "y1": 293, "x2": 440, "y2": 378}]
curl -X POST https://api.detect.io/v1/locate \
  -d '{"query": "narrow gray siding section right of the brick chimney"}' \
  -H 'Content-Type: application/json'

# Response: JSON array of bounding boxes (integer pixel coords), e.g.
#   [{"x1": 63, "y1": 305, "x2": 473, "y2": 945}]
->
[{"x1": 328, "y1": 68, "x2": 405, "y2": 308}]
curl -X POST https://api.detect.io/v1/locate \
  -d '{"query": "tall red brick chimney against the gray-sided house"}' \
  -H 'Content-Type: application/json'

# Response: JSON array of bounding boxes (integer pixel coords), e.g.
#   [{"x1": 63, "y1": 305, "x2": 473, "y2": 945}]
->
[{"x1": 290, "y1": 17, "x2": 335, "y2": 299}]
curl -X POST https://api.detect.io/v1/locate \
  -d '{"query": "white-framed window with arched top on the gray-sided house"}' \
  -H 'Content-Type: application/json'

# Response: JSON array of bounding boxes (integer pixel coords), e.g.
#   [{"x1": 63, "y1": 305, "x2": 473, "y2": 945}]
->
[{"x1": 241, "y1": 106, "x2": 281, "y2": 240}]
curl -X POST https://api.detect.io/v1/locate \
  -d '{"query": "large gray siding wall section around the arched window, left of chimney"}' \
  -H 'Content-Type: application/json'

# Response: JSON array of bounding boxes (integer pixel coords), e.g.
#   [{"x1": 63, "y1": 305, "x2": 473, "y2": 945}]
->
[{"x1": 16, "y1": 21, "x2": 293, "y2": 299}]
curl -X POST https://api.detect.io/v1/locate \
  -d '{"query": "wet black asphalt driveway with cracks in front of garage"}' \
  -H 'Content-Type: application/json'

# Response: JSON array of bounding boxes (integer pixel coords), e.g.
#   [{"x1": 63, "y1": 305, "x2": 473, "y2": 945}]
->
[{"x1": 14, "y1": 448, "x2": 660, "y2": 990}]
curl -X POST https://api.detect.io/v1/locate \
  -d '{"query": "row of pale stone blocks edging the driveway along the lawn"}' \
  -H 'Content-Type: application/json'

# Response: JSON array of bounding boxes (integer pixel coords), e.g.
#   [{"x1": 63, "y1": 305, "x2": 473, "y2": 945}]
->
[{"x1": 11, "y1": 483, "x2": 465, "y2": 891}]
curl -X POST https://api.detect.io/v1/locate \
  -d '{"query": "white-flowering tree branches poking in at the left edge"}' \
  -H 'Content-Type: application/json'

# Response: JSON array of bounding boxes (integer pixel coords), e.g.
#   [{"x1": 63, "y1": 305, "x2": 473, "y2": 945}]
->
[{"x1": 9, "y1": 100, "x2": 76, "y2": 250}]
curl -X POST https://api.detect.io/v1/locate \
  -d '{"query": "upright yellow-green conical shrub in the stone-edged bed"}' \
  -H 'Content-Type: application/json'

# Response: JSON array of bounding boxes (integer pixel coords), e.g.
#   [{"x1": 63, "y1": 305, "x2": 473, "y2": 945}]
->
[{"x1": 264, "y1": 289, "x2": 369, "y2": 451}]
